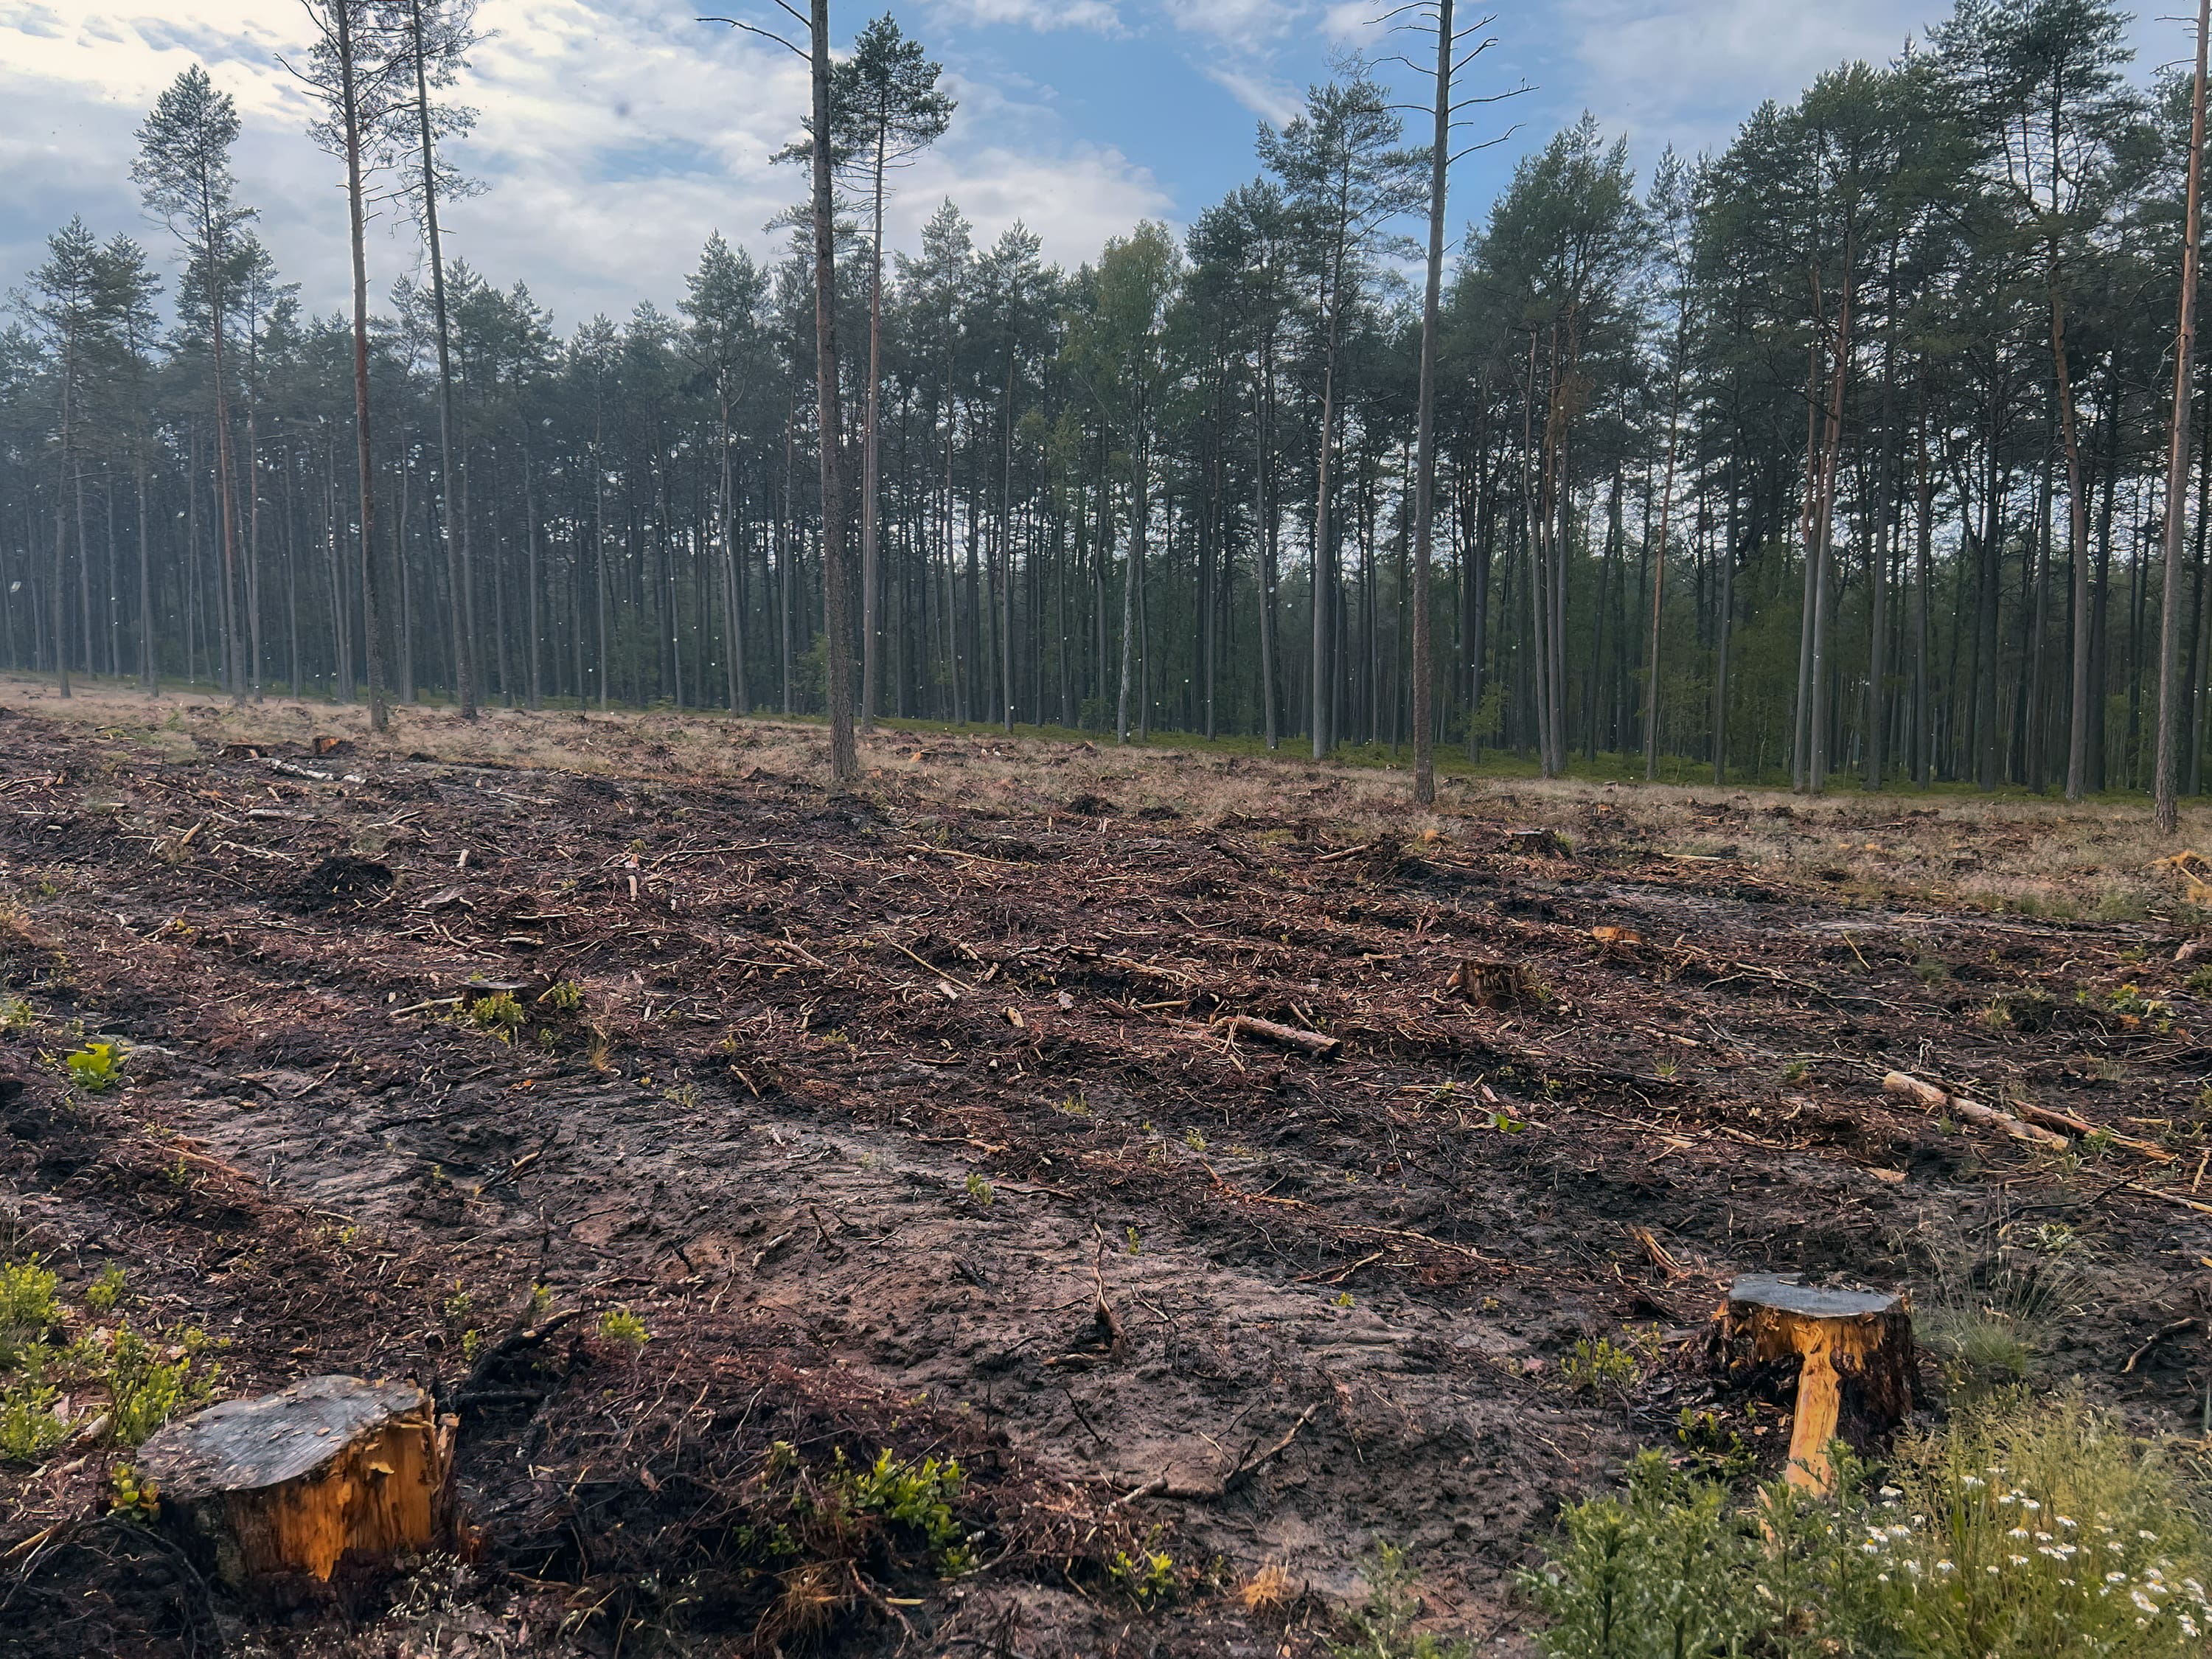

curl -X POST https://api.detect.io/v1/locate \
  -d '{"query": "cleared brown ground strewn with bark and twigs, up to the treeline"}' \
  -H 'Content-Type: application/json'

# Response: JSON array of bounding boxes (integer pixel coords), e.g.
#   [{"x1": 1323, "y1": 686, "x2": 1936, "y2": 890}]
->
[{"x1": 0, "y1": 681, "x2": 2212, "y2": 1659}]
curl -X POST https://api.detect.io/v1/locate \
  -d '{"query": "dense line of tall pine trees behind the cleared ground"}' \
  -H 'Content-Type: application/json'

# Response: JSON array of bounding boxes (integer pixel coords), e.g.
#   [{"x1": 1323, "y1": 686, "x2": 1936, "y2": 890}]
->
[{"x1": 0, "y1": 0, "x2": 2212, "y2": 792}]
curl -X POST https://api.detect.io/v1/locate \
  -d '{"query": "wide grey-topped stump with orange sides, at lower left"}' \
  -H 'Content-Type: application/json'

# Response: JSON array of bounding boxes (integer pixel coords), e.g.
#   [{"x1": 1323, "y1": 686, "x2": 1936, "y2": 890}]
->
[{"x1": 139, "y1": 1376, "x2": 458, "y2": 1586}]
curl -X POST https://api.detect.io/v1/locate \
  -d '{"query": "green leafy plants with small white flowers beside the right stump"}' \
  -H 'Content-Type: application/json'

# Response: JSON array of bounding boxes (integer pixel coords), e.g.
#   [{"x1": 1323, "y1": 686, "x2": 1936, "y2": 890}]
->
[{"x1": 1524, "y1": 1391, "x2": 2212, "y2": 1659}]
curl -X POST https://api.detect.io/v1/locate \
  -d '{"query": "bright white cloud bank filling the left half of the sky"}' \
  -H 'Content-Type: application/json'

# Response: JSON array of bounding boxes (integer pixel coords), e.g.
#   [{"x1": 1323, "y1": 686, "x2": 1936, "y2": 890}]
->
[{"x1": 0, "y1": 0, "x2": 1170, "y2": 325}]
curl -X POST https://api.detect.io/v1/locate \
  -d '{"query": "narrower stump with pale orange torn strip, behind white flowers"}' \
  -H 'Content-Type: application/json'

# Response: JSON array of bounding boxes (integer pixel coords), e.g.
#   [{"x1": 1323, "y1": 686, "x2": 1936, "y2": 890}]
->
[{"x1": 1721, "y1": 1274, "x2": 1913, "y2": 1491}]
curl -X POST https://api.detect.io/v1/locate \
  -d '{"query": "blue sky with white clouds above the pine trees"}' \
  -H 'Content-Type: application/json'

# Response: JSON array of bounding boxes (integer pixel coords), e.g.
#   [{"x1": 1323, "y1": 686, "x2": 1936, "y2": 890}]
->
[{"x1": 0, "y1": 0, "x2": 2183, "y2": 327}]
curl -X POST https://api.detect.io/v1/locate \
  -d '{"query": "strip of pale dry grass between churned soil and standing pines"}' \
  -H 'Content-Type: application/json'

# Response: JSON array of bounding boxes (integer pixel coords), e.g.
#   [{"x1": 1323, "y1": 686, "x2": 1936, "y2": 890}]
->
[{"x1": 0, "y1": 677, "x2": 2212, "y2": 925}]
